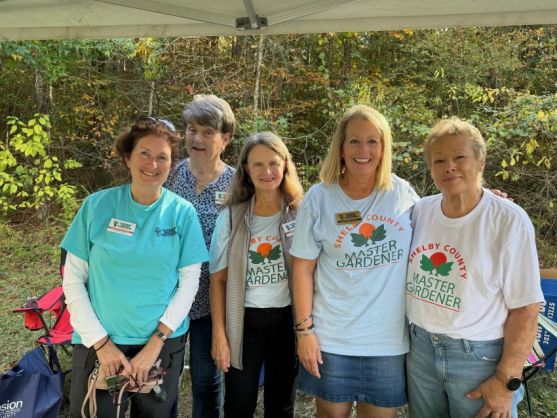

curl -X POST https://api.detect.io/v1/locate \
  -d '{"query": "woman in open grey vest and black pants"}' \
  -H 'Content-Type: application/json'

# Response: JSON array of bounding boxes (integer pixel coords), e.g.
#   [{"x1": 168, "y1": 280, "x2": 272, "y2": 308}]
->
[{"x1": 209, "y1": 132, "x2": 303, "y2": 418}]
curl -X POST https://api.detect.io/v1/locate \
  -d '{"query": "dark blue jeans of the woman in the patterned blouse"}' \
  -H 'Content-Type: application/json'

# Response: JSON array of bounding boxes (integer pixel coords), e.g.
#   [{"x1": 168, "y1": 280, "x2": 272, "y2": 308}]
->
[{"x1": 188, "y1": 315, "x2": 223, "y2": 418}]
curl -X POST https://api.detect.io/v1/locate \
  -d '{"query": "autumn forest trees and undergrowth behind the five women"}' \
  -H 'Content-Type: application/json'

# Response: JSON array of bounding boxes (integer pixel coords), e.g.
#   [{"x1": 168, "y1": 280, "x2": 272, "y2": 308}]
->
[{"x1": 0, "y1": 25, "x2": 557, "y2": 416}]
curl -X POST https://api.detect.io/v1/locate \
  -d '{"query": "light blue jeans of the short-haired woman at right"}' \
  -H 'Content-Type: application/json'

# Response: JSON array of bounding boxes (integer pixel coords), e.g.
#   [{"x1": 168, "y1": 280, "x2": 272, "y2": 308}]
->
[{"x1": 406, "y1": 324, "x2": 524, "y2": 418}]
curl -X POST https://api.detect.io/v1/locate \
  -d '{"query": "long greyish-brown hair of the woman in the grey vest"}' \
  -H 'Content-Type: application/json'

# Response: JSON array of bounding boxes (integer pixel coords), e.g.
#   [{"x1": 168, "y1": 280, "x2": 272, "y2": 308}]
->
[{"x1": 225, "y1": 132, "x2": 304, "y2": 209}]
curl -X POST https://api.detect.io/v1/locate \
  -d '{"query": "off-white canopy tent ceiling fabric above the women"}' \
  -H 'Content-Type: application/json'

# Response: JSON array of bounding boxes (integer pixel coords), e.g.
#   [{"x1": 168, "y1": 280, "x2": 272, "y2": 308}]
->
[{"x1": 0, "y1": 0, "x2": 557, "y2": 40}]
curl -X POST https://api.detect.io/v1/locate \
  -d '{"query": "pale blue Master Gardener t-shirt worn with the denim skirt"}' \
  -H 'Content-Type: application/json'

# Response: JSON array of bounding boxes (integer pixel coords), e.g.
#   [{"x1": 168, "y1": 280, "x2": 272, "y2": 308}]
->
[{"x1": 290, "y1": 176, "x2": 419, "y2": 356}]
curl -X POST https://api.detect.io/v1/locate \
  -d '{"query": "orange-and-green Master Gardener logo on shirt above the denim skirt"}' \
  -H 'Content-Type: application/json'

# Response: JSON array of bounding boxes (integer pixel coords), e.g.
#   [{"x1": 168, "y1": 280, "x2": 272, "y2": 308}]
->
[{"x1": 335, "y1": 214, "x2": 405, "y2": 270}]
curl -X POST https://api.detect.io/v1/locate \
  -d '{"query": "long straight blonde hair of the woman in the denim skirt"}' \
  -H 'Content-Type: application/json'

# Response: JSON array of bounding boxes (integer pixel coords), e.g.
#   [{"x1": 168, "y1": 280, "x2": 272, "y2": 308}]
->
[{"x1": 319, "y1": 105, "x2": 393, "y2": 190}]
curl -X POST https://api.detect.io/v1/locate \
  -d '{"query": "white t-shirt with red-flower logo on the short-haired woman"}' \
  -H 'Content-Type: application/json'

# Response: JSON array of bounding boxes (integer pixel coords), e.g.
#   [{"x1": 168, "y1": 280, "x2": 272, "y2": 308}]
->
[{"x1": 406, "y1": 190, "x2": 543, "y2": 341}]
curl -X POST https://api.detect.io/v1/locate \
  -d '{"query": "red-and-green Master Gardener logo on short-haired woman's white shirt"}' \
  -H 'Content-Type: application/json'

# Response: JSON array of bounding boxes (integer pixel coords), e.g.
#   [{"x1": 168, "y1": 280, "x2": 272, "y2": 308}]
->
[{"x1": 406, "y1": 242, "x2": 467, "y2": 312}]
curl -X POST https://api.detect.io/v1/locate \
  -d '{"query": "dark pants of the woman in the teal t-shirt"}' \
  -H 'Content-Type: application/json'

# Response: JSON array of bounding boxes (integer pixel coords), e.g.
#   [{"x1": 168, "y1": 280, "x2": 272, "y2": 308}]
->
[{"x1": 70, "y1": 335, "x2": 186, "y2": 418}]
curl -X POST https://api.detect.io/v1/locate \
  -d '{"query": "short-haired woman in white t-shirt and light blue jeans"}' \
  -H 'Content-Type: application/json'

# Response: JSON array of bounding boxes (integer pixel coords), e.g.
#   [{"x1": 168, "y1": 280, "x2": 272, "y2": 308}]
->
[{"x1": 406, "y1": 118, "x2": 543, "y2": 418}]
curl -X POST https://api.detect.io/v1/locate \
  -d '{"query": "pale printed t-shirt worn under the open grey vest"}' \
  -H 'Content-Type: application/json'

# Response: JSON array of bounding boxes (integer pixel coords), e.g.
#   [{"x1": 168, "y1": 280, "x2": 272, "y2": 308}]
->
[{"x1": 209, "y1": 209, "x2": 291, "y2": 308}]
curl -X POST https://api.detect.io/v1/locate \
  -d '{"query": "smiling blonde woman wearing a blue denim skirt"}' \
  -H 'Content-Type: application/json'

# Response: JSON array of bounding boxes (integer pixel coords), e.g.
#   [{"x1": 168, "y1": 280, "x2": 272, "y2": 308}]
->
[{"x1": 290, "y1": 105, "x2": 418, "y2": 418}]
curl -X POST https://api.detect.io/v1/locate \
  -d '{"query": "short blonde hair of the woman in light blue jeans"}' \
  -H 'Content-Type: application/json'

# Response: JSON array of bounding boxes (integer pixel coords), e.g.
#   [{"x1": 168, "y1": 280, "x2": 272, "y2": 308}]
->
[{"x1": 424, "y1": 116, "x2": 487, "y2": 167}]
